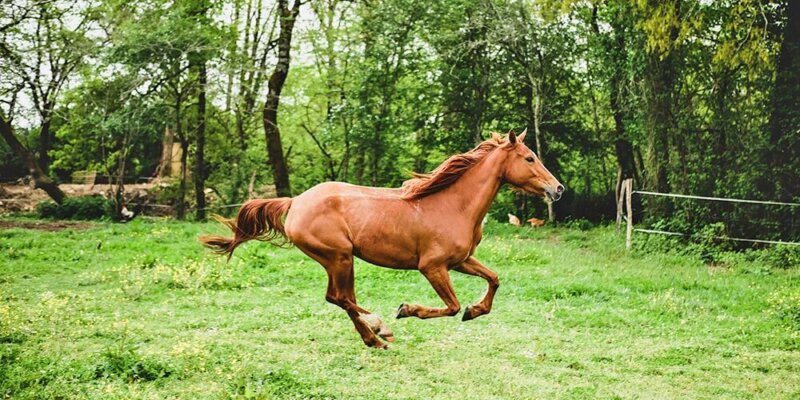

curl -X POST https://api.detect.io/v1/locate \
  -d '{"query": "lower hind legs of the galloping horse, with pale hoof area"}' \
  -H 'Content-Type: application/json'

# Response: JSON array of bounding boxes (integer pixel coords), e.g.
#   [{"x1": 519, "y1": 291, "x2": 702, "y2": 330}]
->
[{"x1": 323, "y1": 256, "x2": 394, "y2": 349}]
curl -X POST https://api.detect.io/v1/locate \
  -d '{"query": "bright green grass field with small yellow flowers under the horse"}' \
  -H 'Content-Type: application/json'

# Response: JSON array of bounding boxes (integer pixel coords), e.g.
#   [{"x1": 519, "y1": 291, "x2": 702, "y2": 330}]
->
[{"x1": 0, "y1": 219, "x2": 800, "y2": 399}]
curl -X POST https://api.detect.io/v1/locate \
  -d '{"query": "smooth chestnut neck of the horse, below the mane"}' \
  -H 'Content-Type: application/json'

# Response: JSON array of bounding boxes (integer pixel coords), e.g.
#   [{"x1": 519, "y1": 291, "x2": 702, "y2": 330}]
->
[{"x1": 434, "y1": 150, "x2": 504, "y2": 224}]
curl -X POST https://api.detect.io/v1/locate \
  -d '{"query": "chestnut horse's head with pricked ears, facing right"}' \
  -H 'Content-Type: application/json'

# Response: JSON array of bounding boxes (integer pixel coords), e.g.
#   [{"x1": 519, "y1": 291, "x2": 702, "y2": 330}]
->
[{"x1": 503, "y1": 129, "x2": 564, "y2": 201}]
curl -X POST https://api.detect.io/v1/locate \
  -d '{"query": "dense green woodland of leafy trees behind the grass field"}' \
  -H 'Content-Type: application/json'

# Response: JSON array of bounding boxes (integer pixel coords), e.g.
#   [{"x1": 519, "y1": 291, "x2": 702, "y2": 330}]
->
[{"x1": 0, "y1": 0, "x2": 800, "y2": 240}]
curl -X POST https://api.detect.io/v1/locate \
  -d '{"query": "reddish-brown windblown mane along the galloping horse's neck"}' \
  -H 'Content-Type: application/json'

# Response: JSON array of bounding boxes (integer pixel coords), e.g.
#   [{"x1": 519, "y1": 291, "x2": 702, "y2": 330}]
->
[{"x1": 402, "y1": 134, "x2": 505, "y2": 200}]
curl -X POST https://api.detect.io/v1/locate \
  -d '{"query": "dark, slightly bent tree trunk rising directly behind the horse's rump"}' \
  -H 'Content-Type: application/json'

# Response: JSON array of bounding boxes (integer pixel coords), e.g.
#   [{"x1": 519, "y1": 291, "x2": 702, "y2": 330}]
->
[{"x1": 263, "y1": 0, "x2": 301, "y2": 197}]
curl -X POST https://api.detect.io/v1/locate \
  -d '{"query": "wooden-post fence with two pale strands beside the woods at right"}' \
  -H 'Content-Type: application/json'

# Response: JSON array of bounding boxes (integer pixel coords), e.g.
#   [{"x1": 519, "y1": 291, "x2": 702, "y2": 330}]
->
[{"x1": 617, "y1": 179, "x2": 800, "y2": 249}]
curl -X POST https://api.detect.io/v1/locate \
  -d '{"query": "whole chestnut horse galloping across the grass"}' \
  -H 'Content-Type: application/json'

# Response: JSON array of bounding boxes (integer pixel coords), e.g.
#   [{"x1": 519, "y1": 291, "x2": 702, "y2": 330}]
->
[{"x1": 200, "y1": 131, "x2": 564, "y2": 348}]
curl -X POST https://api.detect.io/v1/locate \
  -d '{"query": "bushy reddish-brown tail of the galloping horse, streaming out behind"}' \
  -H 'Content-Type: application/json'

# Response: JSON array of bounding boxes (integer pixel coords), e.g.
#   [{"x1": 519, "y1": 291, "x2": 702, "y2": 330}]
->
[{"x1": 200, "y1": 197, "x2": 292, "y2": 259}]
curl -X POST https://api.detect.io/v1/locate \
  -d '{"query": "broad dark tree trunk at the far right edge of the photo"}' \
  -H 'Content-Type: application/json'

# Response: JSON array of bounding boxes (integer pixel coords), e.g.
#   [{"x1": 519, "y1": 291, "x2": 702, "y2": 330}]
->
[{"x1": 766, "y1": 1, "x2": 800, "y2": 201}]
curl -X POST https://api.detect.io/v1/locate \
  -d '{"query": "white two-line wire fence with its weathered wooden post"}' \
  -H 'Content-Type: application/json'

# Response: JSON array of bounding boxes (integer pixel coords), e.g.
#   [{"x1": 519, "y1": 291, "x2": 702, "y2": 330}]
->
[{"x1": 617, "y1": 186, "x2": 800, "y2": 248}]
